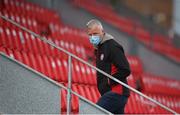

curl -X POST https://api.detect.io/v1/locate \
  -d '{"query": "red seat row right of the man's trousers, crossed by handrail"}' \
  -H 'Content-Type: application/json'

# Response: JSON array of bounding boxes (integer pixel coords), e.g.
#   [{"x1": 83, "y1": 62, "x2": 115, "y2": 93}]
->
[{"x1": 125, "y1": 92, "x2": 180, "y2": 114}]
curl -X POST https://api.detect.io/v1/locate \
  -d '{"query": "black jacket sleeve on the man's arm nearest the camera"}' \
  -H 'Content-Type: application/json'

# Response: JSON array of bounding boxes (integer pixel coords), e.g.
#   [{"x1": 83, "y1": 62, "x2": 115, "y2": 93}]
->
[{"x1": 110, "y1": 43, "x2": 131, "y2": 80}]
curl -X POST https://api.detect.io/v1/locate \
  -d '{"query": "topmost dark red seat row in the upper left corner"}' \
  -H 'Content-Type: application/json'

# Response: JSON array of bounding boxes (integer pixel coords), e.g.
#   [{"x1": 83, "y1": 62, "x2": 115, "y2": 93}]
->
[{"x1": 3, "y1": 0, "x2": 60, "y2": 23}]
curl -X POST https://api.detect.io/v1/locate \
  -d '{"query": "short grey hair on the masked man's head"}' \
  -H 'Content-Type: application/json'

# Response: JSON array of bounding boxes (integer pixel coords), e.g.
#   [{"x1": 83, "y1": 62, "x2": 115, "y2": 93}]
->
[{"x1": 86, "y1": 19, "x2": 103, "y2": 30}]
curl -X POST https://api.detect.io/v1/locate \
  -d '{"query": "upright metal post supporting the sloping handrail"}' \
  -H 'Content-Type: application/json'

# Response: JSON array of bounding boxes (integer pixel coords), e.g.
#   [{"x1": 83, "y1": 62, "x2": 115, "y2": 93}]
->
[{"x1": 67, "y1": 55, "x2": 72, "y2": 115}]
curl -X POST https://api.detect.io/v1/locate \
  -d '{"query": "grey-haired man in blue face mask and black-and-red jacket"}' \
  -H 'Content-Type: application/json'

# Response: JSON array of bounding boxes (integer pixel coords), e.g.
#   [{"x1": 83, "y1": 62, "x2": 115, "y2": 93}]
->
[{"x1": 87, "y1": 19, "x2": 130, "y2": 114}]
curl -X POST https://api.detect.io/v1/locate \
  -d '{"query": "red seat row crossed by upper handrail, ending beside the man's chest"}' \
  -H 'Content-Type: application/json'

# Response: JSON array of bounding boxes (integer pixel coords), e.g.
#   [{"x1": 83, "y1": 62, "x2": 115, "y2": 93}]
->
[{"x1": 0, "y1": 26, "x2": 90, "y2": 59}]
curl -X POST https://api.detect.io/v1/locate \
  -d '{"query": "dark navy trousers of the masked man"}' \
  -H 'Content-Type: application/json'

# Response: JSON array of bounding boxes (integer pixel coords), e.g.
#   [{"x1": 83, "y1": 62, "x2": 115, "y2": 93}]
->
[{"x1": 97, "y1": 91, "x2": 128, "y2": 114}]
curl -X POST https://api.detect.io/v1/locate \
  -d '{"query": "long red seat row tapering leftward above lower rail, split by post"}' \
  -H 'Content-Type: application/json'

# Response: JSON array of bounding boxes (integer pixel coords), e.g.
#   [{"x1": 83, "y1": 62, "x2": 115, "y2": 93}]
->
[{"x1": 1, "y1": 47, "x2": 97, "y2": 85}]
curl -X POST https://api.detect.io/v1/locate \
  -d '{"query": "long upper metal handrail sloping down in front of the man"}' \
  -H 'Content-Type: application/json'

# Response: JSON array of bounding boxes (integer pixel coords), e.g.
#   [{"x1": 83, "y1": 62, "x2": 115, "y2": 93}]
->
[{"x1": 0, "y1": 15, "x2": 178, "y2": 114}]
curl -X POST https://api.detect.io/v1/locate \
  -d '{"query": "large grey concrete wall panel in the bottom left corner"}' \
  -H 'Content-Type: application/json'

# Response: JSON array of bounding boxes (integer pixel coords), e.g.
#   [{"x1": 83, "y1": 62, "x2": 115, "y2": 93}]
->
[{"x1": 0, "y1": 54, "x2": 61, "y2": 114}]
